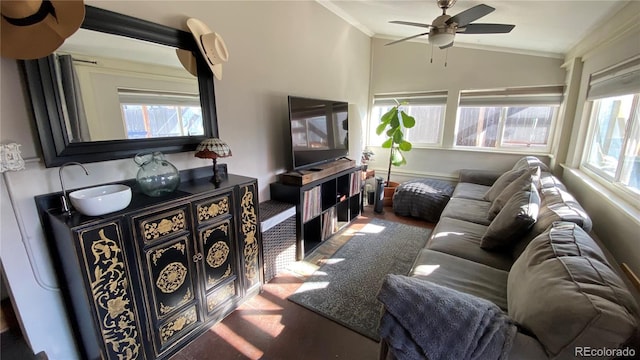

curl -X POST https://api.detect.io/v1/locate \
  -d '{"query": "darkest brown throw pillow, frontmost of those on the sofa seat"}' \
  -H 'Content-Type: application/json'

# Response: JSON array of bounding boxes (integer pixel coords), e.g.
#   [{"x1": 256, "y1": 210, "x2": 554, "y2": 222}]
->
[{"x1": 480, "y1": 184, "x2": 540, "y2": 250}]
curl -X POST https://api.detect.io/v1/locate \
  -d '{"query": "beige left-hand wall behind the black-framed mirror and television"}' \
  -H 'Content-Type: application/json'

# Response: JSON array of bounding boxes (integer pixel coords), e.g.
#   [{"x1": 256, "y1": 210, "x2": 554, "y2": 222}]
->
[{"x1": 0, "y1": 1, "x2": 371, "y2": 360}]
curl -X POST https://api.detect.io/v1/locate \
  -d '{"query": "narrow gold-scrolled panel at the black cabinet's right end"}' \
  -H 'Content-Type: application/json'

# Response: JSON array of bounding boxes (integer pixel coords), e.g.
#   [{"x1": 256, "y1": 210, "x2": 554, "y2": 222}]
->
[{"x1": 238, "y1": 183, "x2": 264, "y2": 293}]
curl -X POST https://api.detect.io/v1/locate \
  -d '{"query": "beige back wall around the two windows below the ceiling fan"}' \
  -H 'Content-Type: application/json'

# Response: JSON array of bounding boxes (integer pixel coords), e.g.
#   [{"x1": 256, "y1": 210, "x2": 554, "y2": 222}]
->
[{"x1": 364, "y1": 38, "x2": 565, "y2": 181}]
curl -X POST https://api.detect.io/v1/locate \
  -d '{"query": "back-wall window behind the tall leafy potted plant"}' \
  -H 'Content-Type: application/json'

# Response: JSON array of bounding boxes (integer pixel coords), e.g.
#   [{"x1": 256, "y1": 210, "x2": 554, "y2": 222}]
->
[{"x1": 369, "y1": 92, "x2": 447, "y2": 146}]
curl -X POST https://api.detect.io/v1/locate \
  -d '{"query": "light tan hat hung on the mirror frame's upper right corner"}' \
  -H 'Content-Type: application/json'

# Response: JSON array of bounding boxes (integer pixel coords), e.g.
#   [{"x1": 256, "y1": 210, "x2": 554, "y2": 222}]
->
[{"x1": 183, "y1": 18, "x2": 229, "y2": 80}]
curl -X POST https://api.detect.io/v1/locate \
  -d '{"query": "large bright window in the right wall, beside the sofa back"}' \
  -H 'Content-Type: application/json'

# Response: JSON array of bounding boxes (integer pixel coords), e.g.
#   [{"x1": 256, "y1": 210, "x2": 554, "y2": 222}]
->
[{"x1": 582, "y1": 58, "x2": 640, "y2": 195}]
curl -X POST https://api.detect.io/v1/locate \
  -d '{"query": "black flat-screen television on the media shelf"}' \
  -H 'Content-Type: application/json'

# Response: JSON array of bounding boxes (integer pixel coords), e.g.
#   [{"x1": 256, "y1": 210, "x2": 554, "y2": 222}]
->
[{"x1": 289, "y1": 96, "x2": 349, "y2": 170}]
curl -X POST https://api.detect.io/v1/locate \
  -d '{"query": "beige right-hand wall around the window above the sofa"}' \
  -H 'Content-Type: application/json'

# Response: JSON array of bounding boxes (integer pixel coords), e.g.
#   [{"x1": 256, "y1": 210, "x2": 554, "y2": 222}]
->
[{"x1": 559, "y1": 1, "x2": 640, "y2": 282}]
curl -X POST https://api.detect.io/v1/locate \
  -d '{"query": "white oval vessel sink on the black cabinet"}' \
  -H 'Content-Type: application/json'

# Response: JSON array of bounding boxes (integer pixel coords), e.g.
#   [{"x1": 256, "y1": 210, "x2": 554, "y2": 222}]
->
[{"x1": 69, "y1": 184, "x2": 131, "y2": 216}]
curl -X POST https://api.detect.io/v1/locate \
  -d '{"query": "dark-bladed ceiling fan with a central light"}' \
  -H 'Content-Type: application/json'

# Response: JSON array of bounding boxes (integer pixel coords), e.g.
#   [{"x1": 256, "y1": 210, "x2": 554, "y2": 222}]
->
[{"x1": 386, "y1": 0, "x2": 515, "y2": 49}]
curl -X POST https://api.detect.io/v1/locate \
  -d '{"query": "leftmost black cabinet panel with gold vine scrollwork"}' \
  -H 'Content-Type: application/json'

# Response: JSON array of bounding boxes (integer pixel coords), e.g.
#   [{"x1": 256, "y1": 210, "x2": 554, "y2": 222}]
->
[{"x1": 75, "y1": 221, "x2": 144, "y2": 359}]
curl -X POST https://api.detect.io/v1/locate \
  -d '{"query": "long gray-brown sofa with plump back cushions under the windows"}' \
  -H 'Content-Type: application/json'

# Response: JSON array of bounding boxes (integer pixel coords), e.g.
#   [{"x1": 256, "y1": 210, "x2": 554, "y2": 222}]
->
[{"x1": 381, "y1": 157, "x2": 638, "y2": 359}]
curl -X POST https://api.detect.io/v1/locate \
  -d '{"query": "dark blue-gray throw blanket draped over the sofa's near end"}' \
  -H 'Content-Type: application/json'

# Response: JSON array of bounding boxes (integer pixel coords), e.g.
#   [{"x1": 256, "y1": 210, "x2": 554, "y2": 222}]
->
[{"x1": 378, "y1": 275, "x2": 517, "y2": 360}]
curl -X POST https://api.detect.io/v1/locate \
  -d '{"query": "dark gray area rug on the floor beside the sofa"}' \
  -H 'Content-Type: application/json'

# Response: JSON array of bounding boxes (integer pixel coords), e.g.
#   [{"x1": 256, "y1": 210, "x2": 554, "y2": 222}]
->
[{"x1": 289, "y1": 219, "x2": 430, "y2": 341}]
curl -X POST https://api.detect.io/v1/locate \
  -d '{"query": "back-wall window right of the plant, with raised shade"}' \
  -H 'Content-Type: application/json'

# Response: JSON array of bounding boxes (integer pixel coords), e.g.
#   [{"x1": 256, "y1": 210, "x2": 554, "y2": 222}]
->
[{"x1": 455, "y1": 86, "x2": 562, "y2": 152}]
